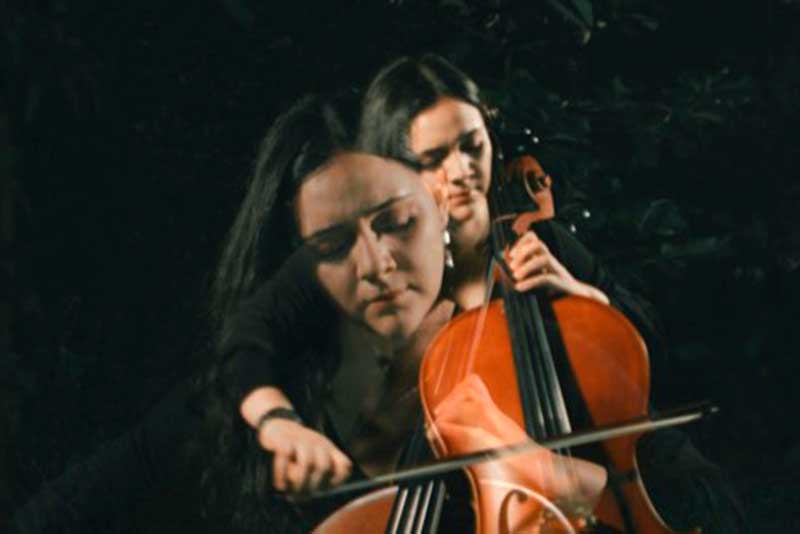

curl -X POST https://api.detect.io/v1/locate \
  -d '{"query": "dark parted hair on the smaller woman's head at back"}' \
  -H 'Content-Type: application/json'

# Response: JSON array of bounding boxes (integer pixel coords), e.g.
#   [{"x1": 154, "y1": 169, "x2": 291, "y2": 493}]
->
[{"x1": 359, "y1": 54, "x2": 503, "y2": 182}]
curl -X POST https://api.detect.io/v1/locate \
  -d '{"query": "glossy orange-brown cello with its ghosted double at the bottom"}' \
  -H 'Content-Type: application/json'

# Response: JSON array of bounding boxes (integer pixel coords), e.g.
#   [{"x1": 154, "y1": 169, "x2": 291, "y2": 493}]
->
[{"x1": 315, "y1": 154, "x2": 696, "y2": 534}]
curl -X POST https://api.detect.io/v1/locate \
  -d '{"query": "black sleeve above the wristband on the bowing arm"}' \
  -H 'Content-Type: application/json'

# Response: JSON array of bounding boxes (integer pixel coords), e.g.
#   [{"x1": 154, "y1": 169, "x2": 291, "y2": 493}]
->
[{"x1": 221, "y1": 249, "x2": 334, "y2": 399}]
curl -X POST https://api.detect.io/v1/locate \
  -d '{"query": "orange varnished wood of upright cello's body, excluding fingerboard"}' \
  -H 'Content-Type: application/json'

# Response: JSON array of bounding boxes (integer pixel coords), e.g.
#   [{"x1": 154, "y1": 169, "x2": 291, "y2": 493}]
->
[{"x1": 420, "y1": 296, "x2": 688, "y2": 534}]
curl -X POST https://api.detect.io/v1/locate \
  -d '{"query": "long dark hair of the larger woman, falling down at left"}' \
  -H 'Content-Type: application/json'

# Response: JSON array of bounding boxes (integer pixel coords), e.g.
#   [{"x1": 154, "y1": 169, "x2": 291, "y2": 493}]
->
[{"x1": 202, "y1": 96, "x2": 357, "y2": 533}]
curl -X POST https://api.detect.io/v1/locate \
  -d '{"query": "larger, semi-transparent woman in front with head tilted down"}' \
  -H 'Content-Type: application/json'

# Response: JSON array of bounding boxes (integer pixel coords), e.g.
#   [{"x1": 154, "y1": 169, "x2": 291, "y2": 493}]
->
[{"x1": 208, "y1": 93, "x2": 605, "y2": 531}]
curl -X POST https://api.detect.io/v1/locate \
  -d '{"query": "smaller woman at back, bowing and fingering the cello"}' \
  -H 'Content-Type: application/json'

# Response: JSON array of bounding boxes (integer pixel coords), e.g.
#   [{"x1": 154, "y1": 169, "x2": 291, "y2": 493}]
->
[{"x1": 223, "y1": 56, "x2": 739, "y2": 532}]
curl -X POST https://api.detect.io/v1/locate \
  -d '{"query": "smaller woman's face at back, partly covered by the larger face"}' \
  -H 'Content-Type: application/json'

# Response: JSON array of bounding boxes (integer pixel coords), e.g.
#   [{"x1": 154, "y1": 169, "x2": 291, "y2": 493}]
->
[{"x1": 409, "y1": 97, "x2": 492, "y2": 234}]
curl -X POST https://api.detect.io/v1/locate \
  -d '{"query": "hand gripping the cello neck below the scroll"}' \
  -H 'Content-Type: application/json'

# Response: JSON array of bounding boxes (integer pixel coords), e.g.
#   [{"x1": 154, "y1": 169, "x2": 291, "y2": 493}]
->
[{"x1": 505, "y1": 230, "x2": 608, "y2": 304}]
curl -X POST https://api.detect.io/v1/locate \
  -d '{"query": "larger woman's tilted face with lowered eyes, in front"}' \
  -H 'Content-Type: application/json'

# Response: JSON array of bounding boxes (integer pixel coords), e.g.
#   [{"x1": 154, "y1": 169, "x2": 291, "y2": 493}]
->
[{"x1": 296, "y1": 153, "x2": 446, "y2": 341}]
